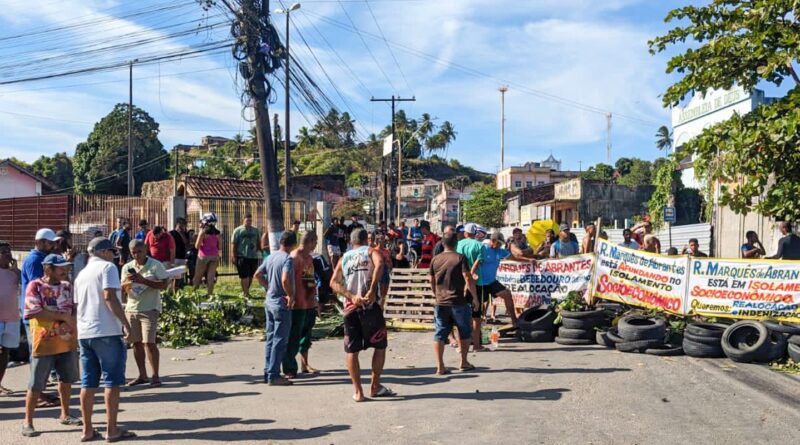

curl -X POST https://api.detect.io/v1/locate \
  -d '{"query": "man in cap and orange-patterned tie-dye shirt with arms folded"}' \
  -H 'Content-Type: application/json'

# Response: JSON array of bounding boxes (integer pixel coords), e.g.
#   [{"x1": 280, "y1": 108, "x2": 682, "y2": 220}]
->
[{"x1": 22, "y1": 254, "x2": 81, "y2": 437}]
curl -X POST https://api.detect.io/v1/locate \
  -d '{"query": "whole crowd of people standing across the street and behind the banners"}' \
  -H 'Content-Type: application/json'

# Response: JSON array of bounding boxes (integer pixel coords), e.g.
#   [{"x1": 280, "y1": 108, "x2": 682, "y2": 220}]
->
[{"x1": 0, "y1": 214, "x2": 800, "y2": 442}]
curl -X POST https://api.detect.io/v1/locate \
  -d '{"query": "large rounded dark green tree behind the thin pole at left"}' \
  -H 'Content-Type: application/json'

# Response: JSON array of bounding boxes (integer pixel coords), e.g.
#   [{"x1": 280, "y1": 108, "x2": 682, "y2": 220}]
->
[{"x1": 72, "y1": 104, "x2": 169, "y2": 195}]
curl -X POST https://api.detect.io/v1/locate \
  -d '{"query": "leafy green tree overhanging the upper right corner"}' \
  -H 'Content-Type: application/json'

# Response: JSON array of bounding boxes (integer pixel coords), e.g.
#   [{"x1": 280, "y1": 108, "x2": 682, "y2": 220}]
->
[{"x1": 649, "y1": 0, "x2": 800, "y2": 221}]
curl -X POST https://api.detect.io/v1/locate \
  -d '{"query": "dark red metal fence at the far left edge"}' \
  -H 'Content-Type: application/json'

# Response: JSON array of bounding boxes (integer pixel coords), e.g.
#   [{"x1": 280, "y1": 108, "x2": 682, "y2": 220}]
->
[{"x1": 0, "y1": 195, "x2": 69, "y2": 250}]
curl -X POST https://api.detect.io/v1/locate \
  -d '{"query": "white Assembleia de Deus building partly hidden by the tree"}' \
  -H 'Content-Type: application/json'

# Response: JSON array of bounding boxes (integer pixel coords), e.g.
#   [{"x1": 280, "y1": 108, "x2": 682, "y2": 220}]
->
[{"x1": 672, "y1": 87, "x2": 773, "y2": 189}]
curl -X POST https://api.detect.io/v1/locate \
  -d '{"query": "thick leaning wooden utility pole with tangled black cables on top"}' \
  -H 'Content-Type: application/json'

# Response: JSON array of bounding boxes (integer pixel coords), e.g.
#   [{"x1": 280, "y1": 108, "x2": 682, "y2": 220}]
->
[{"x1": 239, "y1": 0, "x2": 285, "y2": 252}]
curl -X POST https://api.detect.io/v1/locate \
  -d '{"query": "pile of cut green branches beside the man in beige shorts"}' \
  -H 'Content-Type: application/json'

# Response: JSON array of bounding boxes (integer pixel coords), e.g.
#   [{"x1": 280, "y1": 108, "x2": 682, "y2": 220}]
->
[{"x1": 158, "y1": 288, "x2": 251, "y2": 348}]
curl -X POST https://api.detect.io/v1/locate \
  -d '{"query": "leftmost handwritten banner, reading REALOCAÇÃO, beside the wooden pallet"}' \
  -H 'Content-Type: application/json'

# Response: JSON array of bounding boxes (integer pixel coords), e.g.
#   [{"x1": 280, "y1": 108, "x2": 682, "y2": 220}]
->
[{"x1": 497, "y1": 253, "x2": 594, "y2": 307}]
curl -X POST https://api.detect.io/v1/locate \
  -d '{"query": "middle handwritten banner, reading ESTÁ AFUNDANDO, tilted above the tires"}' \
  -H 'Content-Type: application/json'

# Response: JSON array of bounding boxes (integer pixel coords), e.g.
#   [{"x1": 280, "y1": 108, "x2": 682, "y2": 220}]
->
[{"x1": 593, "y1": 240, "x2": 689, "y2": 314}]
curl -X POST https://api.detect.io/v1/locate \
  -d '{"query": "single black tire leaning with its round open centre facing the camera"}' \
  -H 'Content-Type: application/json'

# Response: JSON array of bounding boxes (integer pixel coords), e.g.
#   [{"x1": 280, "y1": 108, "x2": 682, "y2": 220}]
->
[{"x1": 722, "y1": 320, "x2": 783, "y2": 363}]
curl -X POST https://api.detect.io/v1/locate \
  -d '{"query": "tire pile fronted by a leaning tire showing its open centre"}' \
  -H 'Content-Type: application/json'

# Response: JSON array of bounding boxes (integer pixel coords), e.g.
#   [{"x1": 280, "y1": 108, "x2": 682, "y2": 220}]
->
[{"x1": 721, "y1": 320, "x2": 788, "y2": 363}]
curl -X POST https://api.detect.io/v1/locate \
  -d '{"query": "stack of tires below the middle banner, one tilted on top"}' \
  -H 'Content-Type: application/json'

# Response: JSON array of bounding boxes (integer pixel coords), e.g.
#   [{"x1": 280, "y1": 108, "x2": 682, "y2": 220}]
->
[{"x1": 606, "y1": 315, "x2": 683, "y2": 356}]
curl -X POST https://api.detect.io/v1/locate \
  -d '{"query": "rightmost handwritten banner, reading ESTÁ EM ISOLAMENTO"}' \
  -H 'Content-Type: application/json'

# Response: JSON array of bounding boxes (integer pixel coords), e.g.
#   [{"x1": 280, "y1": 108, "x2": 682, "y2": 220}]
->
[{"x1": 686, "y1": 258, "x2": 800, "y2": 322}]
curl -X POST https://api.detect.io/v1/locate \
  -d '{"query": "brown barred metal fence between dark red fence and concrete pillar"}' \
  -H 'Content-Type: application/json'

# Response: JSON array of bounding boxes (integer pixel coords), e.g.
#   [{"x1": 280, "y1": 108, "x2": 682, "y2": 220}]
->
[{"x1": 69, "y1": 195, "x2": 172, "y2": 247}]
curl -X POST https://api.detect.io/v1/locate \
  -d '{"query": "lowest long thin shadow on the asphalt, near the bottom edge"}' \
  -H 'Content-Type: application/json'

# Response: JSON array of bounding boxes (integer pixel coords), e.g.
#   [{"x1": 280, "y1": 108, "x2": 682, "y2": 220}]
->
[{"x1": 141, "y1": 423, "x2": 350, "y2": 442}]
